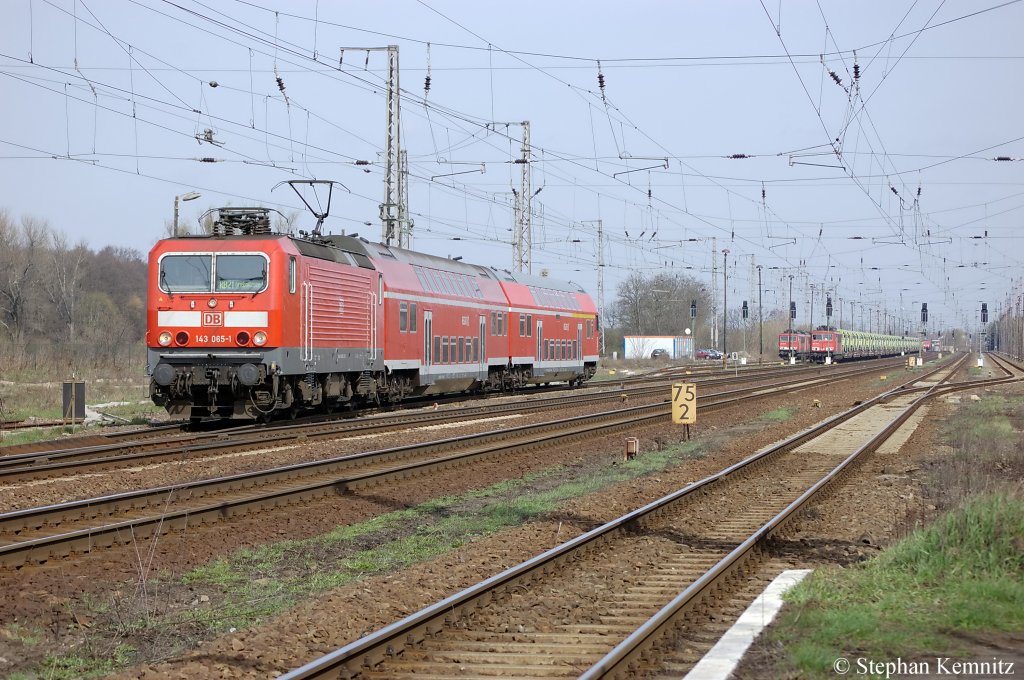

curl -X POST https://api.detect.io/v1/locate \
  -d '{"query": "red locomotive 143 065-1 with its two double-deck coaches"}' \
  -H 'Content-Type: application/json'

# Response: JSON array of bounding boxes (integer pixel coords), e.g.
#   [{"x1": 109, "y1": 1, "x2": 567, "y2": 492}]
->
[{"x1": 146, "y1": 208, "x2": 599, "y2": 420}]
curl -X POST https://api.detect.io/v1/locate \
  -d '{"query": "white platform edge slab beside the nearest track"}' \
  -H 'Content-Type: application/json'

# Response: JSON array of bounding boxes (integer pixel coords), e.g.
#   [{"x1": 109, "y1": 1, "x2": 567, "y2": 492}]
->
[{"x1": 685, "y1": 569, "x2": 811, "y2": 680}]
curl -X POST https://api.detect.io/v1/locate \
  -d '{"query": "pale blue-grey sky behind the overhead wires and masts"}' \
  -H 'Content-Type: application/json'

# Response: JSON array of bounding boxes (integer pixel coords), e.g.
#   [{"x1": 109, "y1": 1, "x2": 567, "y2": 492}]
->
[{"x1": 0, "y1": 0, "x2": 1024, "y2": 335}]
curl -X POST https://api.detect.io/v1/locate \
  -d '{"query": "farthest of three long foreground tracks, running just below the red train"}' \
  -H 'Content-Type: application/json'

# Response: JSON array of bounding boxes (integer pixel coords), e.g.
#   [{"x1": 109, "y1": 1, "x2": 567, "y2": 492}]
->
[{"x1": 0, "y1": 363, "x2": 892, "y2": 483}]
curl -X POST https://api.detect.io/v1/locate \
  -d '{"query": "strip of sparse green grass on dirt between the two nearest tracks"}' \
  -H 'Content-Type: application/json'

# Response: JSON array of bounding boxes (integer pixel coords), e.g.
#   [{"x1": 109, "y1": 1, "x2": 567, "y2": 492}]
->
[{"x1": 183, "y1": 442, "x2": 698, "y2": 630}]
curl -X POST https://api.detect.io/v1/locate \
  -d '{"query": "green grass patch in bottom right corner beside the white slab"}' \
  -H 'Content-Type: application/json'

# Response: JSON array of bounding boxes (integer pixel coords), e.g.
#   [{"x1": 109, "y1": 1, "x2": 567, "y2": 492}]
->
[{"x1": 772, "y1": 494, "x2": 1024, "y2": 678}]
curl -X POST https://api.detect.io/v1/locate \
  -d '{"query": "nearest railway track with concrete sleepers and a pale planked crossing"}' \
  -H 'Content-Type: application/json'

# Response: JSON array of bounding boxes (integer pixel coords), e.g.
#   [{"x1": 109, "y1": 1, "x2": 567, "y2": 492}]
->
[{"x1": 282, "y1": 357, "x2": 1021, "y2": 680}]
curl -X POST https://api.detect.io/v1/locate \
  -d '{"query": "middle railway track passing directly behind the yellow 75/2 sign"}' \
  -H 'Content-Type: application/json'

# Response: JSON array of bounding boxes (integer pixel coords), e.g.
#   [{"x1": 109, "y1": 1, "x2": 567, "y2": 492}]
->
[{"x1": 0, "y1": 352, "x2": 929, "y2": 568}]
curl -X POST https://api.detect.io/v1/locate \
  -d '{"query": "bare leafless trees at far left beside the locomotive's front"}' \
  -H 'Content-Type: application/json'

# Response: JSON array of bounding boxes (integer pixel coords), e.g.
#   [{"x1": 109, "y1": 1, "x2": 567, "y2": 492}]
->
[{"x1": 0, "y1": 210, "x2": 146, "y2": 377}]
